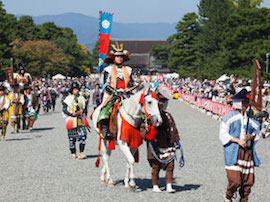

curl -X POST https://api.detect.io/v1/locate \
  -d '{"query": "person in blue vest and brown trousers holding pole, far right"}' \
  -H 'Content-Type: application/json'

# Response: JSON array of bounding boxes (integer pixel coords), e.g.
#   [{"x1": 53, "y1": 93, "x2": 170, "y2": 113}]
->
[{"x1": 219, "y1": 89, "x2": 260, "y2": 202}]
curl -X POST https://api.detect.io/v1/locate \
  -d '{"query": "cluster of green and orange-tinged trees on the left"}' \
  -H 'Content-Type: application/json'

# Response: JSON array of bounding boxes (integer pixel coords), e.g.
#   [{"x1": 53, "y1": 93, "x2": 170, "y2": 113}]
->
[{"x1": 0, "y1": 1, "x2": 94, "y2": 80}]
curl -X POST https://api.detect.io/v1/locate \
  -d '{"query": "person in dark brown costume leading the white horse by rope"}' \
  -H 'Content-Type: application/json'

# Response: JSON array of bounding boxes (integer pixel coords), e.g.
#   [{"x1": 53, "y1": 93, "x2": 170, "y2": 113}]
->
[{"x1": 141, "y1": 93, "x2": 180, "y2": 193}]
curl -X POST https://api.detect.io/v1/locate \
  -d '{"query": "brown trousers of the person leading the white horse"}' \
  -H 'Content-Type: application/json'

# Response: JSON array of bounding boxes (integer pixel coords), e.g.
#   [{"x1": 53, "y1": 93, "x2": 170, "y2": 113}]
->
[{"x1": 149, "y1": 159, "x2": 174, "y2": 185}]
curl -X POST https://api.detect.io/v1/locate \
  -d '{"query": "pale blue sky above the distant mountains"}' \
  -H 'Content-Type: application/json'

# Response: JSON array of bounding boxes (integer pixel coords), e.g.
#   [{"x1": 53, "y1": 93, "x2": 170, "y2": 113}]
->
[{"x1": 2, "y1": 0, "x2": 270, "y2": 23}]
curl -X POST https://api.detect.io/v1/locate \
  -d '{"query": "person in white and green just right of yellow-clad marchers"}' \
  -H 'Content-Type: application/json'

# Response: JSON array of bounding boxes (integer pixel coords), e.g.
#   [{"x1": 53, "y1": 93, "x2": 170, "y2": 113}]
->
[{"x1": 24, "y1": 86, "x2": 38, "y2": 131}]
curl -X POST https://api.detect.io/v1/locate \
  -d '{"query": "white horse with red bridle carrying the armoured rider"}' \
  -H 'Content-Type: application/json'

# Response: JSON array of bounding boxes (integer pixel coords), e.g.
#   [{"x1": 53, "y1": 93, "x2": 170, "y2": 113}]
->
[{"x1": 92, "y1": 87, "x2": 162, "y2": 189}]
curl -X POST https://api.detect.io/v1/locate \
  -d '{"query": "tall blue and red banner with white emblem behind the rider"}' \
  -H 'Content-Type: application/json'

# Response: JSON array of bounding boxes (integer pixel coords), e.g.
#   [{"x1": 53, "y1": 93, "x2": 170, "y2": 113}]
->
[{"x1": 98, "y1": 11, "x2": 113, "y2": 72}]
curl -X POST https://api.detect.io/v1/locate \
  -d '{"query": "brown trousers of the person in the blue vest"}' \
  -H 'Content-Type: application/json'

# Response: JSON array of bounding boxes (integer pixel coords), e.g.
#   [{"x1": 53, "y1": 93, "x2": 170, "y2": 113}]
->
[{"x1": 226, "y1": 148, "x2": 255, "y2": 202}]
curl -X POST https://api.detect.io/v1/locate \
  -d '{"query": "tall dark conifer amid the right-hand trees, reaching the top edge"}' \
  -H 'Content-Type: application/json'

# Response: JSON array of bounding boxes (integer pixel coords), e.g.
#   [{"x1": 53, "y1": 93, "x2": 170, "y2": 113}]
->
[{"x1": 197, "y1": 0, "x2": 233, "y2": 79}]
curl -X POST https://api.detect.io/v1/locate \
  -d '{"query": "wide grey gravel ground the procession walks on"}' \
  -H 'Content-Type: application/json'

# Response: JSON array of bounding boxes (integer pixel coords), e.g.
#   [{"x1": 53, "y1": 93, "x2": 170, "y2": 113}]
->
[{"x1": 0, "y1": 97, "x2": 270, "y2": 202}]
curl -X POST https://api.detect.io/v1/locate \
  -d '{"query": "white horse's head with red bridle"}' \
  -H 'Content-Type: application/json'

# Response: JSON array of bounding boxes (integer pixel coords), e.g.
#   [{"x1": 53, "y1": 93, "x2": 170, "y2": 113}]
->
[{"x1": 140, "y1": 88, "x2": 162, "y2": 127}]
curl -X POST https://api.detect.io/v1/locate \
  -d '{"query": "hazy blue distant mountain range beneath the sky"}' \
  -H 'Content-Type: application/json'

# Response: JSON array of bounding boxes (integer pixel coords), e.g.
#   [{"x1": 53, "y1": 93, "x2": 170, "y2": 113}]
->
[{"x1": 18, "y1": 13, "x2": 176, "y2": 49}]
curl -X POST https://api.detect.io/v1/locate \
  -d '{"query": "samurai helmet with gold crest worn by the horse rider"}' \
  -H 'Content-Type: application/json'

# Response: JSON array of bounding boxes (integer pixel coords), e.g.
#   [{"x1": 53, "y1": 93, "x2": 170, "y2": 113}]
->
[{"x1": 104, "y1": 41, "x2": 130, "y2": 64}]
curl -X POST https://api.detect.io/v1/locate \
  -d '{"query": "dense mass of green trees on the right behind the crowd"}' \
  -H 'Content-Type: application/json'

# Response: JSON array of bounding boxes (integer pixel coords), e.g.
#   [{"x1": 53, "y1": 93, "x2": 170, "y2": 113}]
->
[{"x1": 150, "y1": 0, "x2": 270, "y2": 79}]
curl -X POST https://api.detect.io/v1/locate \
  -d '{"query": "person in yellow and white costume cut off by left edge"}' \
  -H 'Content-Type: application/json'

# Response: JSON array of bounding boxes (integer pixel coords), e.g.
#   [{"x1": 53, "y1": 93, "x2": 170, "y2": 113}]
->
[{"x1": 0, "y1": 85, "x2": 10, "y2": 140}]
